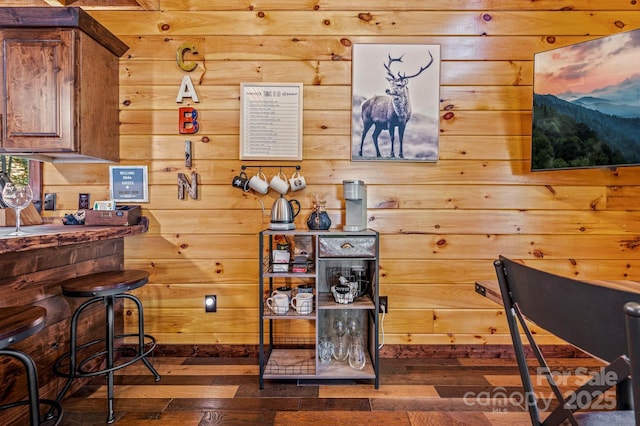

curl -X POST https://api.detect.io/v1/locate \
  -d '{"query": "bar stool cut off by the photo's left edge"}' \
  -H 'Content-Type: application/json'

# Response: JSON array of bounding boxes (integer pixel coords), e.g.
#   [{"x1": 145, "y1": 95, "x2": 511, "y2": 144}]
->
[{"x1": 0, "y1": 306, "x2": 62, "y2": 426}]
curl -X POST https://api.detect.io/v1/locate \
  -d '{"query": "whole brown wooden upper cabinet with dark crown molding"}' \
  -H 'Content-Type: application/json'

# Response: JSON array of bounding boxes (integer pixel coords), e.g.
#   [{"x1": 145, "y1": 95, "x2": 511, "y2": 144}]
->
[{"x1": 0, "y1": 7, "x2": 128, "y2": 162}]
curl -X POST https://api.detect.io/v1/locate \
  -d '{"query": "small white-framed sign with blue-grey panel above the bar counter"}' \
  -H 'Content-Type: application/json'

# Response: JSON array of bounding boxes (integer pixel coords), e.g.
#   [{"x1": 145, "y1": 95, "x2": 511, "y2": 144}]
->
[{"x1": 109, "y1": 166, "x2": 149, "y2": 203}]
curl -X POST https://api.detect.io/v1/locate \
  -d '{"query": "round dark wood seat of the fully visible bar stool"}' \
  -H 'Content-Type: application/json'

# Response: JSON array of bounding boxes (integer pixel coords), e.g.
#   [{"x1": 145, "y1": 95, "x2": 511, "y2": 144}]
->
[{"x1": 60, "y1": 269, "x2": 149, "y2": 297}]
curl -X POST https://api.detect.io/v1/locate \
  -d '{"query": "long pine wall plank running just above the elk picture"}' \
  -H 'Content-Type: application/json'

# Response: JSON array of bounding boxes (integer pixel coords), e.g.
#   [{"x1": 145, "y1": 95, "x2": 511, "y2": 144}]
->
[{"x1": 91, "y1": 10, "x2": 640, "y2": 37}]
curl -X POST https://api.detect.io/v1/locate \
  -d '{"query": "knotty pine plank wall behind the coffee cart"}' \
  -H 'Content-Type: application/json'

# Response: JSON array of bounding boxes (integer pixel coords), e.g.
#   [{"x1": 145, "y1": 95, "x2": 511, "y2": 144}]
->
[{"x1": 27, "y1": 0, "x2": 640, "y2": 345}]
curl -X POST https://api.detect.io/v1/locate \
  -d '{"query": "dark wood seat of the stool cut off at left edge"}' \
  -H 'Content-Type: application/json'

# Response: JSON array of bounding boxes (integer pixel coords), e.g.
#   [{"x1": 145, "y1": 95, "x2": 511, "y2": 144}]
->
[{"x1": 0, "y1": 306, "x2": 47, "y2": 349}]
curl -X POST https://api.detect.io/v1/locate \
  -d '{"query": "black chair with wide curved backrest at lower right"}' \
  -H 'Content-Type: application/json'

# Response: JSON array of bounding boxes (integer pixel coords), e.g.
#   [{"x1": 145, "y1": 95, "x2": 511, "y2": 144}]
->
[{"x1": 494, "y1": 256, "x2": 640, "y2": 425}]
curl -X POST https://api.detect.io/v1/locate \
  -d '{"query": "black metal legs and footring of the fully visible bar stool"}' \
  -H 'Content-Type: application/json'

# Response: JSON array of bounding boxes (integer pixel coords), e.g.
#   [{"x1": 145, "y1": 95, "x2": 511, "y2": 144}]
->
[{"x1": 53, "y1": 293, "x2": 160, "y2": 423}]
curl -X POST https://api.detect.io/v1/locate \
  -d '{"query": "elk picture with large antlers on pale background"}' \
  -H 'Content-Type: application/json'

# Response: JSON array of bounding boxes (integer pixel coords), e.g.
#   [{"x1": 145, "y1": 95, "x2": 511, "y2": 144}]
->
[{"x1": 351, "y1": 44, "x2": 440, "y2": 161}]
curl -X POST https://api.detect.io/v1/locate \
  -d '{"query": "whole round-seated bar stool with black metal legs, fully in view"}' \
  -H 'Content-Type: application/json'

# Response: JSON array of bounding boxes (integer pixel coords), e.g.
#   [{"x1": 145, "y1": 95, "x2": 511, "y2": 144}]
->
[{"x1": 53, "y1": 270, "x2": 160, "y2": 423}]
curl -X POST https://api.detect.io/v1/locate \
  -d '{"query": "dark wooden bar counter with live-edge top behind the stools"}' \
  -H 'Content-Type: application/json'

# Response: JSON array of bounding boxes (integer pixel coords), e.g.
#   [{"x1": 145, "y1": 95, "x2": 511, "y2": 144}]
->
[{"x1": 0, "y1": 217, "x2": 148, "y2": 424}]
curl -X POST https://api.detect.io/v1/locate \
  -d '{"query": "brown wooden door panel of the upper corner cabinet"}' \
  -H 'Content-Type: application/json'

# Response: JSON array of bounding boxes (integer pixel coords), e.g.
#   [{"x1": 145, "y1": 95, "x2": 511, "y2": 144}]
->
[{"x1": 0, "y1": 29, "x2": 75, "y2": 153}]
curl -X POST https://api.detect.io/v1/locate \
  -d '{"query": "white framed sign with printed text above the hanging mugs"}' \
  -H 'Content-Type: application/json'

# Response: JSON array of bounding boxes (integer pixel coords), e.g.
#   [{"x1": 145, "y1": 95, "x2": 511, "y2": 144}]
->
[{"x1": 240, "y1": 83, "x2": 302, "y2": 160}]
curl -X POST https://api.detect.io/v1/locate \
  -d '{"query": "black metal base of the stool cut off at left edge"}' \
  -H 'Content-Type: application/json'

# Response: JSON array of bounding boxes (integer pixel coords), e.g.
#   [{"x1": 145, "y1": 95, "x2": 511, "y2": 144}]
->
[{"x1": 0, "y1": 349, "x2": 63, "y2": 426}]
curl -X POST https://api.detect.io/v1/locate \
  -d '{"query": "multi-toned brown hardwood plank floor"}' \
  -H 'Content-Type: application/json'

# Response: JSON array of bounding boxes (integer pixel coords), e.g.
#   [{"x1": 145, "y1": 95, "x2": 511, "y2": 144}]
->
[{"x1": 48, "y1": 357, "x2": 615, "y2": 426}]
